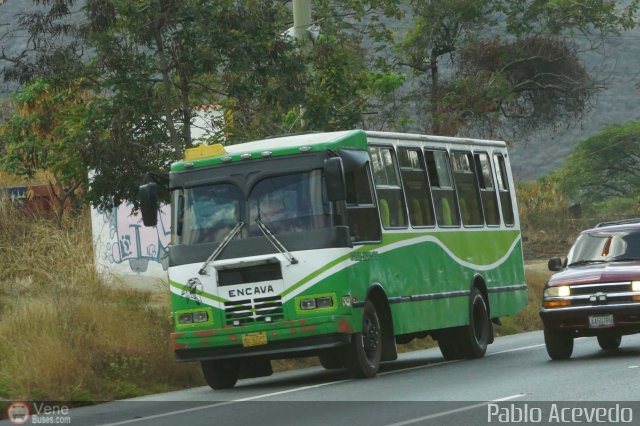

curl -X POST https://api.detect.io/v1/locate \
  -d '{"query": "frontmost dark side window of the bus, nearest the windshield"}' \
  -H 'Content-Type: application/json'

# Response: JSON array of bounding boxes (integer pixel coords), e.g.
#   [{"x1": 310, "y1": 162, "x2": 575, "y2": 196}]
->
[{"x1": 345, "y1": 164, "x2": 382, "y2": 243}]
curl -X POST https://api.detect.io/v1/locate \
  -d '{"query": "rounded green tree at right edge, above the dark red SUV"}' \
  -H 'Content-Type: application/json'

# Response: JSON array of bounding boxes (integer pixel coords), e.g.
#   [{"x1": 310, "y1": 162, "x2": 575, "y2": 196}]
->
[{"x1": 557, "y1": 121, "x2": 640, "y2": 202}]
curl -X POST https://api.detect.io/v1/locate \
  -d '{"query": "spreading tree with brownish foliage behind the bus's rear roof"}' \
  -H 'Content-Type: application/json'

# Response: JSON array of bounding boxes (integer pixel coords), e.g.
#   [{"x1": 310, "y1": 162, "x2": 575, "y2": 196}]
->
[{"x1": 398, "y1": 0, "x2": 638, "y2": 136}]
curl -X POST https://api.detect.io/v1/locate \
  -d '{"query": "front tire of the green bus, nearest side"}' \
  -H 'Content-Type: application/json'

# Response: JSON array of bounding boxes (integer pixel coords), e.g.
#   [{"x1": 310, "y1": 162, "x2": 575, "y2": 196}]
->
[{"x1": 344, "y1": 300, "x2": 382, "y2": 378}]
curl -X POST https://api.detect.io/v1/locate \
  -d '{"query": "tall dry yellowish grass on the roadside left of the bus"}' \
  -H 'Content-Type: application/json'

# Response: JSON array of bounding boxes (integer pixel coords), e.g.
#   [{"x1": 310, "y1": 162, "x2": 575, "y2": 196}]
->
[{"x1": 0, "y1": 200, "x2": 202, "y2": 401}]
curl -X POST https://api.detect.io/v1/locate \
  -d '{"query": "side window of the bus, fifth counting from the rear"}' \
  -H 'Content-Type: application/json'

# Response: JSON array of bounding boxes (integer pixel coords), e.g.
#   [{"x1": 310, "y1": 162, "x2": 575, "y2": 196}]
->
[{"x1": 398, "y1": 148, "x2": 435, "y2": 226}]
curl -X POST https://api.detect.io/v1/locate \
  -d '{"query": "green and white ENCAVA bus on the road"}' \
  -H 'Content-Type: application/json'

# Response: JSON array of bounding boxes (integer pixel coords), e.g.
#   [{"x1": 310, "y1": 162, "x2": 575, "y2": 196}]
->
[{"x1": 140, "y1": 130, "x2": 527, "y2": 389}]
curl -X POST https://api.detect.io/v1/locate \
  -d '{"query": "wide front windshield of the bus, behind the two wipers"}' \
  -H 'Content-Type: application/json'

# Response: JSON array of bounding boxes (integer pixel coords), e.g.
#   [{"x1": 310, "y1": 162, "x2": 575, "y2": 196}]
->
[{"x1": 172, "y1": 170, "x2": 332, "y2": 244}]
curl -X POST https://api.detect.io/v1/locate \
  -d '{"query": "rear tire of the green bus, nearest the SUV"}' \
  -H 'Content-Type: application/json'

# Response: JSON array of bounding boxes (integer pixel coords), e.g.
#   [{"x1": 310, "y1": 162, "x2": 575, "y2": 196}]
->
[{"x1": 459, "y1": 287, "x2": 493, "y2": 358}]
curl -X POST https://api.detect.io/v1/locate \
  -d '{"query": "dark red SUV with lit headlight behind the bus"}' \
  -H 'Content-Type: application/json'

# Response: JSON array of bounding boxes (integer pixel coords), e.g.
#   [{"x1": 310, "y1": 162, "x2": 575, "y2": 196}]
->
[{"x1": 540, "y1": 219, "x2": 640, "y2": 359}]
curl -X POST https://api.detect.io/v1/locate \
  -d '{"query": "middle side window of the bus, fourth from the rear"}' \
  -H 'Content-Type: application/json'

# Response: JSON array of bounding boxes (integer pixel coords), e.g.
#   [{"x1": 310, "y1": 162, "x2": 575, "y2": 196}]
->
[{"x1": 424, "y1": 150, "x2": 460, "y2": 226}]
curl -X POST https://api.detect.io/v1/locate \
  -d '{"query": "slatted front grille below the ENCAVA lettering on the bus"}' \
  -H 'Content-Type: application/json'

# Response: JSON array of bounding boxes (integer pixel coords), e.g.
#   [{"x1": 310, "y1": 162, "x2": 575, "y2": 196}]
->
[{"x1": 224, "y1": 296, "x2": 284, "y2": 326}]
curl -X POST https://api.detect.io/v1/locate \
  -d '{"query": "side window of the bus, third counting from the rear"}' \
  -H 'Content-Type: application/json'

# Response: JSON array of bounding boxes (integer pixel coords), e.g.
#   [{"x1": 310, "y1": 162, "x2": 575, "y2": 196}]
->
[{"x1": 452, "y1": 151, "x2": 484, "y2": 226}]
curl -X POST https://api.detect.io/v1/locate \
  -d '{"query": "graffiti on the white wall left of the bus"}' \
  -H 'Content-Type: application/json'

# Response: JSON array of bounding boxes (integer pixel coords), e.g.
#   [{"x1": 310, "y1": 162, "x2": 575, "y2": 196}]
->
[{"x1": 101, "y1": 203, "x2": 171, "y2": 273}]
